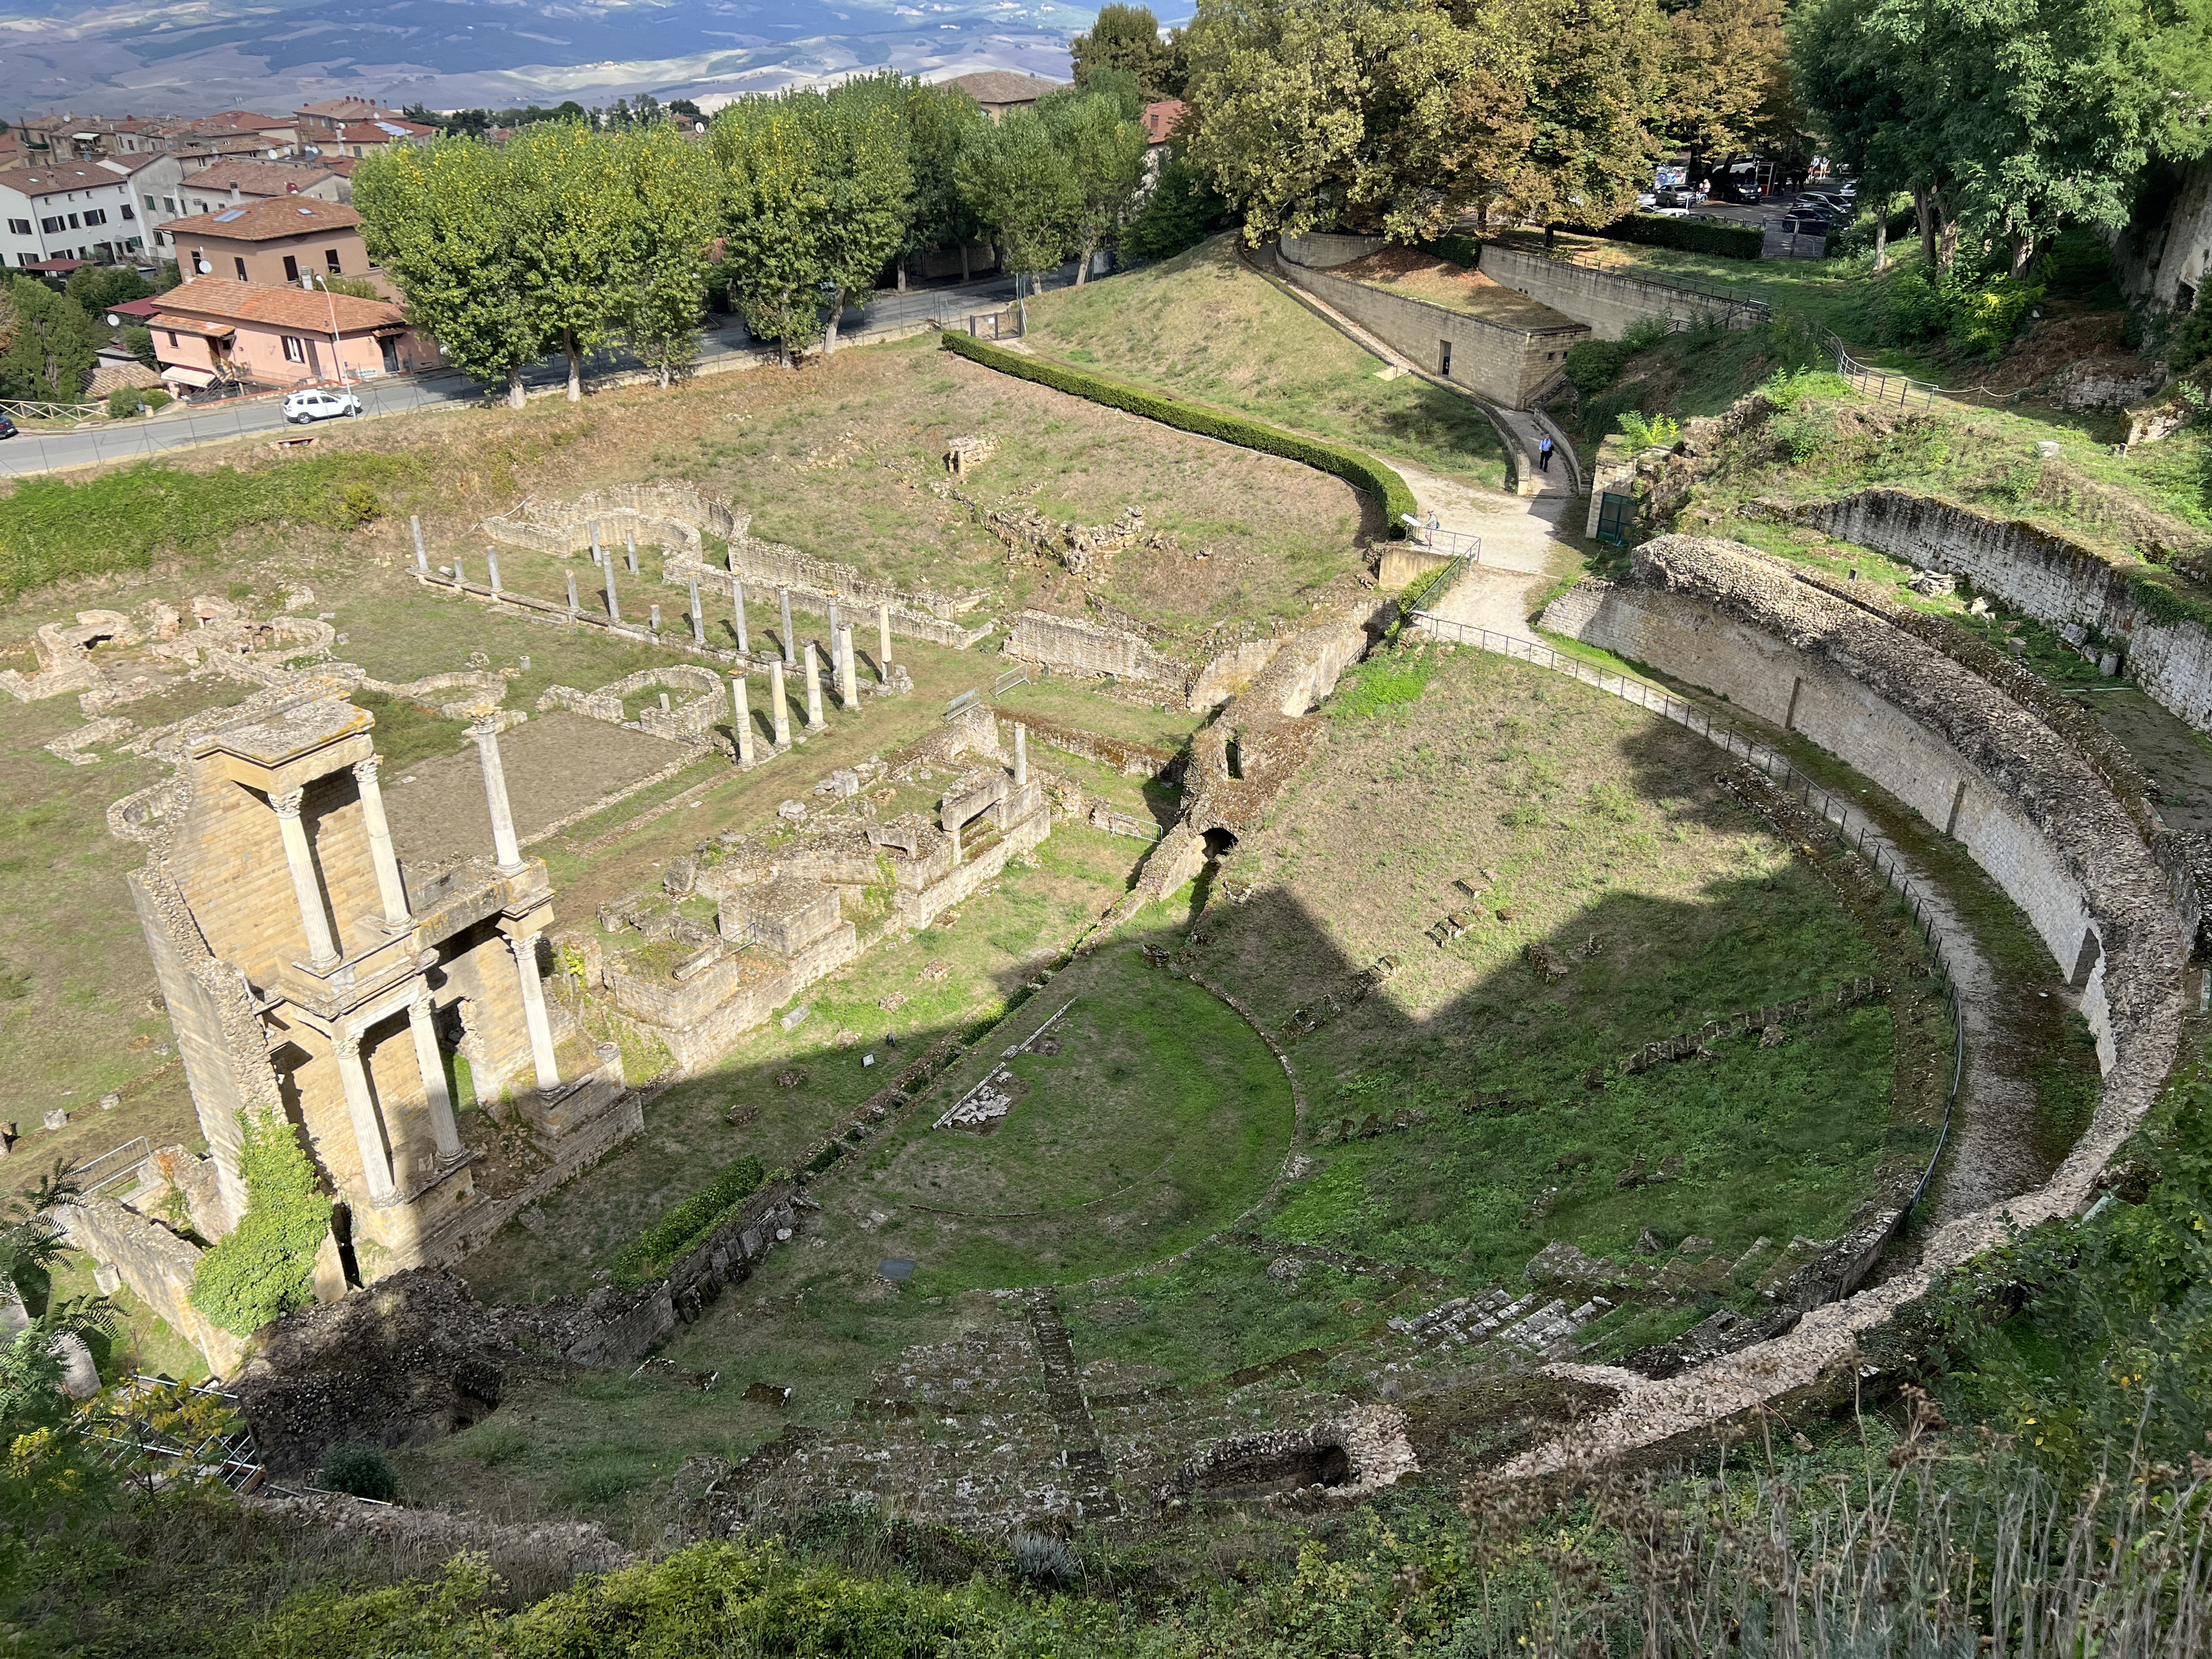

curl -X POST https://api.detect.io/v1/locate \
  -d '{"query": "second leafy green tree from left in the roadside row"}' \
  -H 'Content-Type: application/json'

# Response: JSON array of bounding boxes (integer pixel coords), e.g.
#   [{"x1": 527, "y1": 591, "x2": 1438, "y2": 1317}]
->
[{"x1": 504, "y1": 122, "x2": 650, "y2": 403}]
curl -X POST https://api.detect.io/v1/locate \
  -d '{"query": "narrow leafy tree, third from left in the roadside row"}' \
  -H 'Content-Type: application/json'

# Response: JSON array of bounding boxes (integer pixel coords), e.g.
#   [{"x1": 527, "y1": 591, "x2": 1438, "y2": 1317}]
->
[{"x1": 619, "y1": 122, "x2": 721, "y2": 385}]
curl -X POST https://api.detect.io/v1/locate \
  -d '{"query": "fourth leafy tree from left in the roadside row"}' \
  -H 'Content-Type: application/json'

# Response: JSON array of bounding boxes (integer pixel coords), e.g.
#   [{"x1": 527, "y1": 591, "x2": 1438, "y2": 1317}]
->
[{"x1": 708, "y1": 93, "x2": 830, "y2": 365}]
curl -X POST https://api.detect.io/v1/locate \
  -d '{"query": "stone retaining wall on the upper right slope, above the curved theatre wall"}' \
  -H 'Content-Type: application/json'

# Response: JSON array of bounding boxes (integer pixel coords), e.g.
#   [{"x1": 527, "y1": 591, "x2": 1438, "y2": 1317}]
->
[{"x1": 1798, "y1": 489, "x2": 2212, "y2": 732}]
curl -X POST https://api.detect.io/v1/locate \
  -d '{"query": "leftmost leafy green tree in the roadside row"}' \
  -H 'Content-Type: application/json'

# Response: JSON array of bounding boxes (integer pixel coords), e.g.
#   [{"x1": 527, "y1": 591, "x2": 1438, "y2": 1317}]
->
[{"x1": 354, "y1": 137, "x2": 553, "y2": 409}]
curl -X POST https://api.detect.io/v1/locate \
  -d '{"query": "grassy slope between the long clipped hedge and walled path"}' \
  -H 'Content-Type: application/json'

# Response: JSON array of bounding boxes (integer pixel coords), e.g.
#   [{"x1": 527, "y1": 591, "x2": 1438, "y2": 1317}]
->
[{"x1": 1029, "y1": 237, "x2": 1504, "y2": 489}]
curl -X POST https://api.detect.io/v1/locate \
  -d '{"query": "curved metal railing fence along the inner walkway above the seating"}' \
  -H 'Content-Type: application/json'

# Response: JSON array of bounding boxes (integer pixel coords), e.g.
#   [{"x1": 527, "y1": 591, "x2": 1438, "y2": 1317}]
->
[{"x1": 1409, "y1": 611, "x2": 1966, "y2": 1223}]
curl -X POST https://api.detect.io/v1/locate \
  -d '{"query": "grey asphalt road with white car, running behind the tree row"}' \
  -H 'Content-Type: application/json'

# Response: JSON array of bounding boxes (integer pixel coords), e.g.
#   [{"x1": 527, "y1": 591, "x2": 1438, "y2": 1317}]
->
[{"x1": 0, "y1": 265, "x2": 1075, "y2": 478}]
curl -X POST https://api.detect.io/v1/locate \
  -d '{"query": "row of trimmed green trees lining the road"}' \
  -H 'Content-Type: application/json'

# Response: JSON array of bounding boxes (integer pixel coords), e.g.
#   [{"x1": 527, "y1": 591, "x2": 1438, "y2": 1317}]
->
[{"x1": 354, "y1": 75, "x2": 1146, "y2": 407}]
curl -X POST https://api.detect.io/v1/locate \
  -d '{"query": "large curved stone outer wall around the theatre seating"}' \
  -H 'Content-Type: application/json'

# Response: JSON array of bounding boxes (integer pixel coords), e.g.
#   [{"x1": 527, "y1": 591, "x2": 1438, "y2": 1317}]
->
[{"x1": 1506, "y1": 535, "x2": 2188, "y2": 1475}]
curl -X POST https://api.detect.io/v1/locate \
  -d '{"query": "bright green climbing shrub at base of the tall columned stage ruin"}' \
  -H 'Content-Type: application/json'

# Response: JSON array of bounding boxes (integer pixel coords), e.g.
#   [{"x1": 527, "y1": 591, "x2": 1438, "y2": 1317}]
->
[{"x1": 192, "y1": 1113, "x2": 330, "y2": 1336}]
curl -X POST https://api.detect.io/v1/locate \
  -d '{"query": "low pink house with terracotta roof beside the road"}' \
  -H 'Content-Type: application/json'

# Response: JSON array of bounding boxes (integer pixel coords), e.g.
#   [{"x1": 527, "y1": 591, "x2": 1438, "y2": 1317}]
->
[{"x1": 146, "y1": 276, "x2": 438, "y2": 394}]
